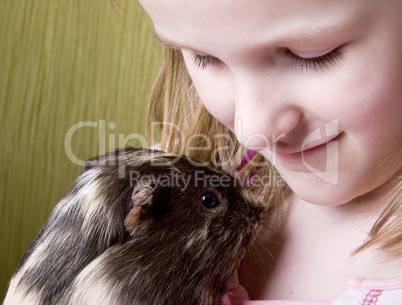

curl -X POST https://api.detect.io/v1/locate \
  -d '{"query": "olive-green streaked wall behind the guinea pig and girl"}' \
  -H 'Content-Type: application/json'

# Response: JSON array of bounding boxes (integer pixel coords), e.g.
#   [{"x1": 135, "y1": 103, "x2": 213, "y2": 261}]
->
[{"x1": 0, "y1": 0, "x2": 162, "y2": 302}]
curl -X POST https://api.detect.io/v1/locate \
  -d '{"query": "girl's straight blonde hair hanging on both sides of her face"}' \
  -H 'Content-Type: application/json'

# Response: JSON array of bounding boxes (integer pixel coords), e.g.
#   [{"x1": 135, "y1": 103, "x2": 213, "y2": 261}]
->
[{"x1": 148, "y1": 48, "x2": 402, "y2": 255}]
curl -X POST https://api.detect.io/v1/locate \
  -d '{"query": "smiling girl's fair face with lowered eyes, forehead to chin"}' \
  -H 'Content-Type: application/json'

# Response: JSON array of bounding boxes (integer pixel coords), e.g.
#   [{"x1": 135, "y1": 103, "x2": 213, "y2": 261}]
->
[{"x1": 140, "y1": 0, "x2": 402, "y2": 205}]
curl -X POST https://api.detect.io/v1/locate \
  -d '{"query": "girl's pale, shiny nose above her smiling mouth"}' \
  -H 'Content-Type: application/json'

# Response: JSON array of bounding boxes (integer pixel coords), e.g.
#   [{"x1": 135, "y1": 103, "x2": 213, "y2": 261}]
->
[{"x1": 234, "y1": 73, "x2": 301, "y2": 150}]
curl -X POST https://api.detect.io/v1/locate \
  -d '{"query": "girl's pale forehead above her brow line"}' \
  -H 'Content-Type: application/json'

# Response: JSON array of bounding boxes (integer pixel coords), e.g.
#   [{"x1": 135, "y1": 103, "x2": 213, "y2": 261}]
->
[{"x1": 140, "y1": 0, "x2": 376, "y2": 48}]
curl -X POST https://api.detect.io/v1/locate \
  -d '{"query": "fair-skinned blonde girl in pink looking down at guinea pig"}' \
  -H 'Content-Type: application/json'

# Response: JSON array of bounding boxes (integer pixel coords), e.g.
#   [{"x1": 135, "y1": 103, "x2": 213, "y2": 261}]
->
[{"x1": 140, "y1": 0, "x2": 402, "y2": 305}]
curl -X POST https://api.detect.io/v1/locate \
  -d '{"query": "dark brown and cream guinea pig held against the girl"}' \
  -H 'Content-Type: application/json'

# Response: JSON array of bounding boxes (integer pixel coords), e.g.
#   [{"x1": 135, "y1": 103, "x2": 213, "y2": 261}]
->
[{"x1": 4, "y1": 147, "x2": 267, "y2": 305}]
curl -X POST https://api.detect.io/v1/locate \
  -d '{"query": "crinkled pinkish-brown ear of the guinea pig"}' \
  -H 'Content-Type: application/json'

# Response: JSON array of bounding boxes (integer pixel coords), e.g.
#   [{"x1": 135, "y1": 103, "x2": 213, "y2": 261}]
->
[{"x1": 124, "y1": 181, "x2": 154, "y2": 234}]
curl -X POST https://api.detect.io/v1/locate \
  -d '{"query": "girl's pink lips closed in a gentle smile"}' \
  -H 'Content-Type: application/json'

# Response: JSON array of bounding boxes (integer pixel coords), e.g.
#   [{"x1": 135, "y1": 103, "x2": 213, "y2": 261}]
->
[{"x1": 274, "y1": 133, "x2": 342, "y2": 163}]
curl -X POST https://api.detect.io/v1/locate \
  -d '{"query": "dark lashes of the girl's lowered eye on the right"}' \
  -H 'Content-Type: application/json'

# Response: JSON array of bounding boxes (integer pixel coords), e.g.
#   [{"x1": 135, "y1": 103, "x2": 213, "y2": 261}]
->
[{"x1": 288, "y1": 47, "x2": 342, "y2": 71}]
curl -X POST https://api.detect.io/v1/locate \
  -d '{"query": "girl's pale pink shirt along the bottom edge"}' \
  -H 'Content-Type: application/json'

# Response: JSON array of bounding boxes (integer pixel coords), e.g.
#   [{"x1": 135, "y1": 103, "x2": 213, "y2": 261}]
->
[{"x1": 222, "y1": 276, "x2": 402, "y2": 305}]
